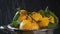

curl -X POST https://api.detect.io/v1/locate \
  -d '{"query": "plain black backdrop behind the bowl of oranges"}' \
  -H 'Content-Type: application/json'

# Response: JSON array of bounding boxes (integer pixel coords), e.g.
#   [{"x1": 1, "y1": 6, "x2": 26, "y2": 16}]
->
[{"x1": 0, "y1": 0, "x2": 60, "y2": 34}]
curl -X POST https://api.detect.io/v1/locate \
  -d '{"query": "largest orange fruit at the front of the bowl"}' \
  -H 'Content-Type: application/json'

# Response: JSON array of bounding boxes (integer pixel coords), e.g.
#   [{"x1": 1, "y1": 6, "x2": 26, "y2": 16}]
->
[{"x1": 19, "y1": 20, "x2": 39, "y2": 30}]
